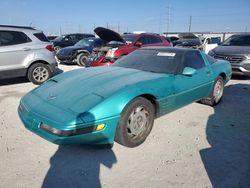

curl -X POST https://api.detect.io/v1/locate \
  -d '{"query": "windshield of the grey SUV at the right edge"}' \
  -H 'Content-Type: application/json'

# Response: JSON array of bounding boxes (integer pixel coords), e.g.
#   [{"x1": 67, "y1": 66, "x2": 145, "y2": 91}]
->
[{"x1": 221, "y1": 35, "x2": 250, "y2": 46}]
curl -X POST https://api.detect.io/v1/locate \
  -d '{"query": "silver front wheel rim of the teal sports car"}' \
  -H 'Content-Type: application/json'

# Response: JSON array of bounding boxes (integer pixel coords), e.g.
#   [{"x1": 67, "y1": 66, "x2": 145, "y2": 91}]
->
[{"x1": 127, "y1": 106, "x2": 149, "y2": 138}]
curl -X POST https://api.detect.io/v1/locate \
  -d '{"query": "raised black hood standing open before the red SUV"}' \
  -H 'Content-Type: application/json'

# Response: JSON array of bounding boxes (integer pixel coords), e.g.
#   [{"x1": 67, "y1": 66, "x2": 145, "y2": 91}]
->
[{"x1": 94, "y1": 27, "x2": 126, "y2": 43}]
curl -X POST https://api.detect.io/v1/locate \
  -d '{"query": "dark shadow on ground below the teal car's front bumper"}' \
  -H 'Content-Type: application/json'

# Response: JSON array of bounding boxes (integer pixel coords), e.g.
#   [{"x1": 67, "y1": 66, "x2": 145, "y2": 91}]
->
[{"x1": 42, "y1": 145, "x2": 117, "y2": 188}]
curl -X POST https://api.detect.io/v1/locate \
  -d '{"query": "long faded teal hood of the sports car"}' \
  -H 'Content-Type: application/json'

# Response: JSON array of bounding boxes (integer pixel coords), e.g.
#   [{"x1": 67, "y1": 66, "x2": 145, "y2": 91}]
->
[{"x1": 33, "y1": 66, "x2": 165, "y2": 113}]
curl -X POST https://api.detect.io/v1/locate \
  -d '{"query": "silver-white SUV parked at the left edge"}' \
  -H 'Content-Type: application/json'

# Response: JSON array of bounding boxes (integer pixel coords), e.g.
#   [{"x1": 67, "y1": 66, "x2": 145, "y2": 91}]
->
[{"x1": 0, "y1": 25, "x2": 57, "y2": 84}]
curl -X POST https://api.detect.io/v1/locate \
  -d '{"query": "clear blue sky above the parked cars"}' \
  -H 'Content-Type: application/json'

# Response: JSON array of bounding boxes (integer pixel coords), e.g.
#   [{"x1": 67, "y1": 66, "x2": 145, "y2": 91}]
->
[{"x1": 0, "y1": 0, "x2": 250, "y2": 35}]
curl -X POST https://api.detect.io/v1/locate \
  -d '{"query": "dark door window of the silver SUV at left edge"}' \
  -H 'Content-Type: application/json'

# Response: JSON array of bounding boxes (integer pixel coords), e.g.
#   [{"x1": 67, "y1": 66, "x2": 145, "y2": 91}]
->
[{"x1": 0, "y1": 31, "x2": 31, "y2": 46}]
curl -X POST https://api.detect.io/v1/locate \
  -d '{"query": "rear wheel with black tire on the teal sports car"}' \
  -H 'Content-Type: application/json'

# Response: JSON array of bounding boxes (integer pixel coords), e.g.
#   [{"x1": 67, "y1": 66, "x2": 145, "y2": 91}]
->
[{"x1": 200, "y1": 76, "x2": 224, "y2": 106}]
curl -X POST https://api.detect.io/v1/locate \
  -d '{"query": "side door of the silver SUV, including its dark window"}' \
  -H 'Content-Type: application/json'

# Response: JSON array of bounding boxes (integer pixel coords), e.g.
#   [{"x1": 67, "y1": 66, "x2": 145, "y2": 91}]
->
[{"x1": 0, "y1": 30, "x2": 31, "y2": 70}]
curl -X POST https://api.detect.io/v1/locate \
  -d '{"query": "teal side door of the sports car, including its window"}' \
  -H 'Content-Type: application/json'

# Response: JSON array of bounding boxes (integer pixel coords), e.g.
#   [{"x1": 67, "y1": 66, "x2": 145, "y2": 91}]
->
[{"x1": 173, "y1": 51, "x2": 213, "y2": 107}]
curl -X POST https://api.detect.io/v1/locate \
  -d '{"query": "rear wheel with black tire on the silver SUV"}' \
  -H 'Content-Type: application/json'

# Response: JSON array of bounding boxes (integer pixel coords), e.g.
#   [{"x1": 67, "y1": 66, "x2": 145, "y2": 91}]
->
[{"x1": 27, "y1": 63, "x2": 51, "y2": 85}]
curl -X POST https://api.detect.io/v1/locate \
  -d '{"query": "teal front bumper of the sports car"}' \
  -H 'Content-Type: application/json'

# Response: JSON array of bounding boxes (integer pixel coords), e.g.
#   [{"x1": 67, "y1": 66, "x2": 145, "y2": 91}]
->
[{"x1": 18, "y1": 103, "x2": 119, "y2": 145}]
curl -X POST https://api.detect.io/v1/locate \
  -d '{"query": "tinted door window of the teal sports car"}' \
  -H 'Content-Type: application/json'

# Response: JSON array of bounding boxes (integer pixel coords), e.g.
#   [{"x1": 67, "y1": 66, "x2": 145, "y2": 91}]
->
[{"x1": 184, "y1": 51, "x2": 205, "y2": 69}]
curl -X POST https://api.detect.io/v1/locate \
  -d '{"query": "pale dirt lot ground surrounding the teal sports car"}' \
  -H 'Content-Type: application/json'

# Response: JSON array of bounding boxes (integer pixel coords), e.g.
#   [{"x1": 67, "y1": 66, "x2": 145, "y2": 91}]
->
[{"x1": 0, "y1": 65, "x2": 250, "y2": 188}]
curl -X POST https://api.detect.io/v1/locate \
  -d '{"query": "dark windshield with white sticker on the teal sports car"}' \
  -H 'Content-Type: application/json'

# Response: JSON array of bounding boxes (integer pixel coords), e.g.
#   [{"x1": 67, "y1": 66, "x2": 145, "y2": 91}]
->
[{"x1": 113, "y1": 49, "x2": 183, "y2": 74}]
